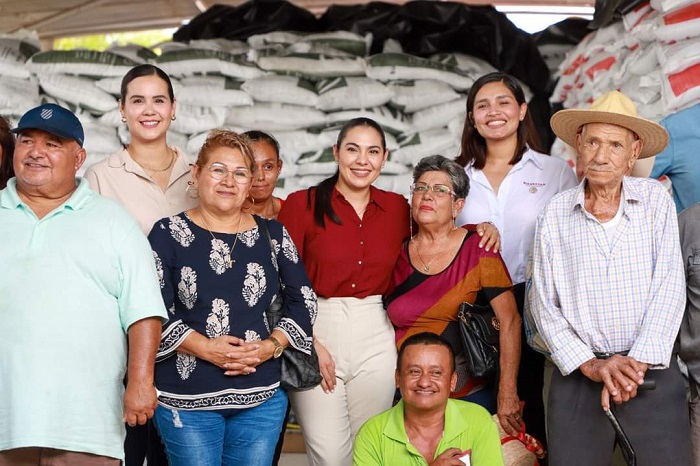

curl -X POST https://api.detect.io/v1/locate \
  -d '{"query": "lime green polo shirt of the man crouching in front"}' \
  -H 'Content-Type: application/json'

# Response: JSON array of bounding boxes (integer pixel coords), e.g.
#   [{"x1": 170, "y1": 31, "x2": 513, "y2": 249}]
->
[{"x1": 353, "y1": 399, "x2": 503, "y2": 466}]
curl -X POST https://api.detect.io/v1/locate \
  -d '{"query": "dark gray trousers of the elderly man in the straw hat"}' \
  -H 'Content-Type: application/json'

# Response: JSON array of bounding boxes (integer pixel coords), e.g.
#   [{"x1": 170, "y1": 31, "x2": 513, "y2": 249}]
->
[{"x1": 547, "y1": 355, "x2": 691, "y2": 466}]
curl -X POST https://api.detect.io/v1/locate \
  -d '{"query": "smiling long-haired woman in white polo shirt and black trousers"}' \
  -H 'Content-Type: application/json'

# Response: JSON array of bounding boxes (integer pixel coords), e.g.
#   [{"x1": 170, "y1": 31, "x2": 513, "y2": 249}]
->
[{"x1": 457, "y1": 72, "x2": 577, "y2": 450}]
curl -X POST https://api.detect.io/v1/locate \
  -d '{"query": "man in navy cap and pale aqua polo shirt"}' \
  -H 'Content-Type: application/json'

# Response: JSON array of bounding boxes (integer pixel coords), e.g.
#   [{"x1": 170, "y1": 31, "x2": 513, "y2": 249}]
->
[{"x1": 0, "y1": 104, "x2": 166, "y2": 466}]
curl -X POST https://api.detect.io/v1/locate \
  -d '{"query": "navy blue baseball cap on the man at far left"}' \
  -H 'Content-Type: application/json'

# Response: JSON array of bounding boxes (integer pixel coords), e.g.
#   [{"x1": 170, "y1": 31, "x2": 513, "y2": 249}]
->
[{"x1": 11, "y1": 104, "x2": 85, "y2": 147}]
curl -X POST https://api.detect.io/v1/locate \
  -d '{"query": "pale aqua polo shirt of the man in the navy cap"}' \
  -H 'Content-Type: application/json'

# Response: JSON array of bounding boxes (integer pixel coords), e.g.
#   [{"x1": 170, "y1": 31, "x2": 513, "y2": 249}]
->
[{"x1": 0, "y1": 179, "x2": 166, "y2": 459}]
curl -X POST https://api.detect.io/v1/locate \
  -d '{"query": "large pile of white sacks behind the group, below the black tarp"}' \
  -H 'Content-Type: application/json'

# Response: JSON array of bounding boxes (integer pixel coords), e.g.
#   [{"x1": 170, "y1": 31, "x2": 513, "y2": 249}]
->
[{"x1": 0, "y1": 31, "x2": 530, "y2": 196}]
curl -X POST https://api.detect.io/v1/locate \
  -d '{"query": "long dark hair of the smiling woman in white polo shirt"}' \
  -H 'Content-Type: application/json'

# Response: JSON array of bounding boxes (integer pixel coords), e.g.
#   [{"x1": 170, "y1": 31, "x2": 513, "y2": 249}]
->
[{"x1": 455, "y1": 72, "x2": 544, "y2": 169}]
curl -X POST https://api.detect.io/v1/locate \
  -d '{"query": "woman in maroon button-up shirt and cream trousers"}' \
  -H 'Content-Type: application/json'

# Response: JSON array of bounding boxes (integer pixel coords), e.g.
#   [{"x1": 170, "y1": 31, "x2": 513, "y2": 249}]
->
[{"x1": 278, "y1": 118, "x2": 497, "y2": 465}]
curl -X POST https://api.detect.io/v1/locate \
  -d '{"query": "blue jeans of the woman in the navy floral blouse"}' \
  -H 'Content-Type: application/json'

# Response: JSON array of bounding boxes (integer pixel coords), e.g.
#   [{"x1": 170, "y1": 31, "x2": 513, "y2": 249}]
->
[{"x1": 153, "y1": 389, "x2": 287, "y2": 466}]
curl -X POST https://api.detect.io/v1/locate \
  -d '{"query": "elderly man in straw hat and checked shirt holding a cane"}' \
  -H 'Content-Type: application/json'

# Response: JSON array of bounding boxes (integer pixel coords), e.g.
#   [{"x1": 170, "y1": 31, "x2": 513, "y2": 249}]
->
[{"x1": 530, "y1": 91, "x2": 690, "y2": 466}]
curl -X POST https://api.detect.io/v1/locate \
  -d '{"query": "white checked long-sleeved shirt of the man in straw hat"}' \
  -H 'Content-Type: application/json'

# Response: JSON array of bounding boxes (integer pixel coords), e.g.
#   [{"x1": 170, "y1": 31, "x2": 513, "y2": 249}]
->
[{"x1": 529, "y1": 177, "x2": 685, "y2": 375}]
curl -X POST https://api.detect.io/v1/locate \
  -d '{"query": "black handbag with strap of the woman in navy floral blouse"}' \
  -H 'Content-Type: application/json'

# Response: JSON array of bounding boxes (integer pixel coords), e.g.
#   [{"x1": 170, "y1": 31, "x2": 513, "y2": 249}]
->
[{"x1": 253, "y1": 215, "x2": 323, "y2": 391}]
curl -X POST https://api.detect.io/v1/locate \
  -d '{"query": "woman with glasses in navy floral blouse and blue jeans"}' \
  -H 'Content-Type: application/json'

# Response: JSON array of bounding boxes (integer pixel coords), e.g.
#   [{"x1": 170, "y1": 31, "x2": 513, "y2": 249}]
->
[{"x1": 149, "y1": 130, "x2": 316, "y2": 466}]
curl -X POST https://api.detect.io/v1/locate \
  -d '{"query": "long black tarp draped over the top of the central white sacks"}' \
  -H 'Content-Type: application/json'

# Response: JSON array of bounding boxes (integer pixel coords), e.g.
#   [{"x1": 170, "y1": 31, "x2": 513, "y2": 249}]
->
[{"x1": 174, "y1": 0, "x2": 549, "y2": 93}]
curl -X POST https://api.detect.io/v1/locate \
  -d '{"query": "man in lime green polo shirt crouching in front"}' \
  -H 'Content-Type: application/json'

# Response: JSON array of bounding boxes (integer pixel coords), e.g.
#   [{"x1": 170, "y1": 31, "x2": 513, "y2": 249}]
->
[{"x1": 353, "y1": 332, "x2": 503, "y2": 466}]
